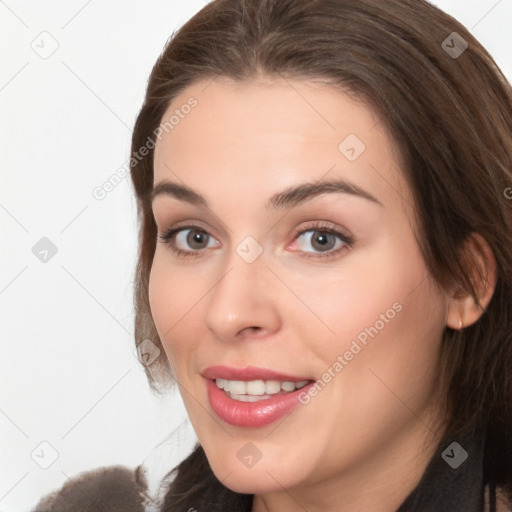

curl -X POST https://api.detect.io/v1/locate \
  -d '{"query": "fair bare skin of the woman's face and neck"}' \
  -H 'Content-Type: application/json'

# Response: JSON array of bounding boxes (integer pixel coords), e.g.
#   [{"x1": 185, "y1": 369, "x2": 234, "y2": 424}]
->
[{"x1": 149, "y1": 77, "x2": 492, "y2": 512}]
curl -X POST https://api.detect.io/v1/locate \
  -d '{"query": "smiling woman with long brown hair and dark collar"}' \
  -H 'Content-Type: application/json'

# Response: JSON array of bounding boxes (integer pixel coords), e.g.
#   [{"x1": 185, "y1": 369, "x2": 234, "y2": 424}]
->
[{"x1": 37, "y1": 0, "x2": 512, "y2": 512}]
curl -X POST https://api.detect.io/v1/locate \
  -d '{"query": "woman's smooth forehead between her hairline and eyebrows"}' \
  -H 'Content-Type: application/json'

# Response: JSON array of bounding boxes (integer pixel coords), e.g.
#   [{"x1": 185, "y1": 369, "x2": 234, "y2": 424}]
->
[{"x1": 154, "y1": 77, "x2": 411, "y2": 217}]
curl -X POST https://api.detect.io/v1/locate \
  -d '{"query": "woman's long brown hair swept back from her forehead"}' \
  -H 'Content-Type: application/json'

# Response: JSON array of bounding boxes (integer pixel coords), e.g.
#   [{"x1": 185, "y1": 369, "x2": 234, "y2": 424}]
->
[{"x1": 131, "y1": 0, "x2": 512, "y2": 510}]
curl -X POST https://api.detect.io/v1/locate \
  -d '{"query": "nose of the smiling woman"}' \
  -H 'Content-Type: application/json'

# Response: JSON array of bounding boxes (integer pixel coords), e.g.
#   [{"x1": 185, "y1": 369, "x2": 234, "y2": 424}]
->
[{"x1": 205, "y1": 245, "x2": 280, "y2": 342}]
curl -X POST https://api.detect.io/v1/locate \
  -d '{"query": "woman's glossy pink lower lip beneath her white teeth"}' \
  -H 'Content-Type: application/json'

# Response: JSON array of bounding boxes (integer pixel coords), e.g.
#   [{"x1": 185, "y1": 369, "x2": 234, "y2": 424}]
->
[{"x1": 206, "y1": 379, "x2": 314, "y2": 427}]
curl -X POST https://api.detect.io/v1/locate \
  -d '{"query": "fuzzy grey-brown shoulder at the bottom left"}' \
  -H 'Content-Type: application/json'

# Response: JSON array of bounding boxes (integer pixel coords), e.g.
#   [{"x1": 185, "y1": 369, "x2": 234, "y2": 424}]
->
[{"x1": 32, "y1": 466, "x2": 144, "y2": 512}]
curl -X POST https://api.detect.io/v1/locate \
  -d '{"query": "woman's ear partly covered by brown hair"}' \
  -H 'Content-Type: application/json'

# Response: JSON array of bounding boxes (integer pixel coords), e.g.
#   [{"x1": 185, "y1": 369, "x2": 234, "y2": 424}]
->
[{"x1": 446, "y1": 233, "x2": 497, "y2": 330}]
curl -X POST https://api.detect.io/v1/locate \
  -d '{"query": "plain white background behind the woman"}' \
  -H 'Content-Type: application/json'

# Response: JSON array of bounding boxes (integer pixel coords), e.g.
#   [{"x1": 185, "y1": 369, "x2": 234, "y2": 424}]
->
[{"x1": 0, "y1": 0, "x2": 512, "y2": 512}]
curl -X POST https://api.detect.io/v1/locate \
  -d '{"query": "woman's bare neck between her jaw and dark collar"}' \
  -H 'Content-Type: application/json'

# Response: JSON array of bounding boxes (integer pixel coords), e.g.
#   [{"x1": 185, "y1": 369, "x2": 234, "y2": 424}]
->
[{"x1": 252, "y1": 410, "x2": 443, "y2": 512}]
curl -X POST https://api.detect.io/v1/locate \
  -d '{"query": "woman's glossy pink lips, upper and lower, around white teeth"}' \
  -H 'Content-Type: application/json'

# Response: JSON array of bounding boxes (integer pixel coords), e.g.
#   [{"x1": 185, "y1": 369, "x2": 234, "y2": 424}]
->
[{"x1": 203, "y1": 366, "x2": 315, "y2": 428}]
